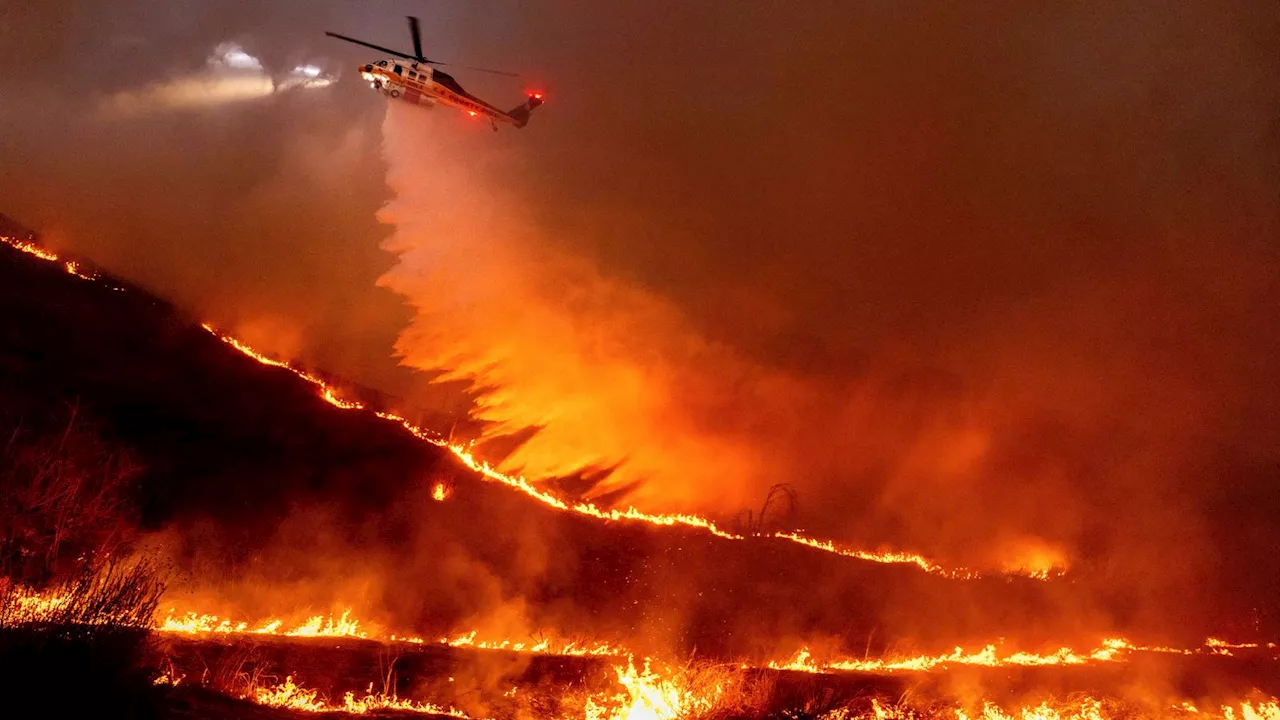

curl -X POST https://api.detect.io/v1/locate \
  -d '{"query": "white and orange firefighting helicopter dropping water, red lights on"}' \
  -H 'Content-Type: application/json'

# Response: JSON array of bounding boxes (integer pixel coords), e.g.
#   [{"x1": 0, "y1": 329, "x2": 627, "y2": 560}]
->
[{"x1": 325, "y1": 15, "x2": 543, "y2": 131}]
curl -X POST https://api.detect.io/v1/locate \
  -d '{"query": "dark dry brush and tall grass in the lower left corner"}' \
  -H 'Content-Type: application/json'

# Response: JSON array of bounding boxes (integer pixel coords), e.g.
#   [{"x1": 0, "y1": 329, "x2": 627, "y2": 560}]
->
[{"x1": 0, "y1": 399, "x2": 164, "y2": 717}]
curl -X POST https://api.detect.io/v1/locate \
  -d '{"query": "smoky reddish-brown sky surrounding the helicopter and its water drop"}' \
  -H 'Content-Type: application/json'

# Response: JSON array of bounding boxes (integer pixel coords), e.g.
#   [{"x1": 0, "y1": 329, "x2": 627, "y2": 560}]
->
[{"x1": 0, "y1": 0, "x2": 1280, "y2": 607}]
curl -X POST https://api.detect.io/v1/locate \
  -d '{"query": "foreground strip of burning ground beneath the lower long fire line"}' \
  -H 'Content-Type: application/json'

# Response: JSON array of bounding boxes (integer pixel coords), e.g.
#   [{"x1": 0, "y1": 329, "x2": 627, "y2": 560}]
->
[{"x1": 147, "y1": 622, "x2": 1280, "y2": 720}]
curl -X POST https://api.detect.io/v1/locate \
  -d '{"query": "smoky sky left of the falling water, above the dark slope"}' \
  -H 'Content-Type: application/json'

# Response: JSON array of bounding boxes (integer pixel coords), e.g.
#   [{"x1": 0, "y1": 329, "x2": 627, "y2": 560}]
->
[{"x1": 0, "y1": 0, "x2": 424, "y2": 391}]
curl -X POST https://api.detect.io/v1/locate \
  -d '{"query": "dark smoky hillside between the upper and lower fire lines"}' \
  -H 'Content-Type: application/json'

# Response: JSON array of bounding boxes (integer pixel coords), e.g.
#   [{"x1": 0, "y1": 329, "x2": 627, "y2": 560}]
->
[{"x1": 0, "y1": 212, "x2": 1090, "y2": 655}]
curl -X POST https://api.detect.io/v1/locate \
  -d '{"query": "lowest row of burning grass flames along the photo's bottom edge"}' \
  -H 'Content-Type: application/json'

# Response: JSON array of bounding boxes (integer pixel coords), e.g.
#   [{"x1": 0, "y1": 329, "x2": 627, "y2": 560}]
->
[{"x1": 177, "y1": 640, "x2": 1280, "y2": 720}]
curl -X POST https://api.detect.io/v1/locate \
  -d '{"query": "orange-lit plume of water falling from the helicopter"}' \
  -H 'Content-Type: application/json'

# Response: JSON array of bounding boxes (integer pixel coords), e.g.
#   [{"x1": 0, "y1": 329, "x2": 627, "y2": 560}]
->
[{"x1": 380, "y1": 105, "x2": 778, "y2": 509}]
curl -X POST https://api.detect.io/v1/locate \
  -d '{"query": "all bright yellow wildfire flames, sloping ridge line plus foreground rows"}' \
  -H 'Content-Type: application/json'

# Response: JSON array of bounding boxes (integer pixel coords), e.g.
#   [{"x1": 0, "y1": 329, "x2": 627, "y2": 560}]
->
[{"x1": 12, "y1": 228, "x2": 1280, "y2": 720}]
